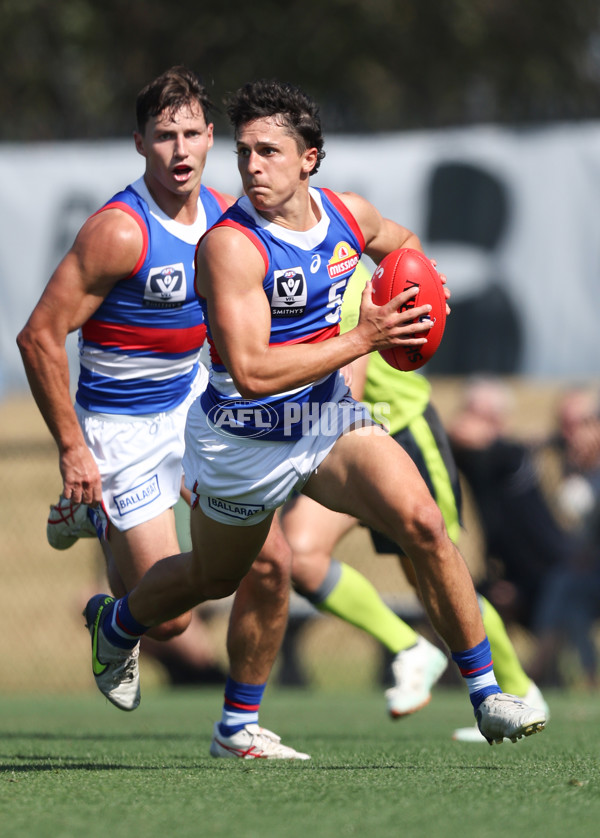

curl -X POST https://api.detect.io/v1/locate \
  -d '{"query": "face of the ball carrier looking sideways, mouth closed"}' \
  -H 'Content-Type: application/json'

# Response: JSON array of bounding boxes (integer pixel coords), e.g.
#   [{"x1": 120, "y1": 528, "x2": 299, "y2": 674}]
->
[{"x1": 237, "y1": 117, "x2": 317, "y2": 223}]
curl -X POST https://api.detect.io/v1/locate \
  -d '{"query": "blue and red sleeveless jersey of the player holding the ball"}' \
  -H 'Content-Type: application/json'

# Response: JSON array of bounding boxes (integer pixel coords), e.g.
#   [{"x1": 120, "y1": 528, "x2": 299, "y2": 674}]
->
[{"x1": 200, "y1": 187, "x2": 364, "y2": 440}]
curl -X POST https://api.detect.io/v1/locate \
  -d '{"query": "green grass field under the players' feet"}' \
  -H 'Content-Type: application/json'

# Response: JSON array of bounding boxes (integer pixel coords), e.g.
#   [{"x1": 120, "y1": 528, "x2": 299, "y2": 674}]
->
[{"x1": 0, "y1": 688, "x2": 600, "y2": 838}]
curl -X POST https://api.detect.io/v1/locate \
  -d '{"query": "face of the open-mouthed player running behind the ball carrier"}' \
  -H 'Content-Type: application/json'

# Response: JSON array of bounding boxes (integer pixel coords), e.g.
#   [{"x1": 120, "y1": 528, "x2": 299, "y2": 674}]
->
[{"x1": 135, "y1": 103, "x2": 213, "y2": 196}]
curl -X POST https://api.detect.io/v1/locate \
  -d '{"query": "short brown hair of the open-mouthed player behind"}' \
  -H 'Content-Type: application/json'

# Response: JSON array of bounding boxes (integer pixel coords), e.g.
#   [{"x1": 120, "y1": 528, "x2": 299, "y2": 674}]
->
[{"x1": 135, "y1": 65, "x2": 213, "y2": 133}]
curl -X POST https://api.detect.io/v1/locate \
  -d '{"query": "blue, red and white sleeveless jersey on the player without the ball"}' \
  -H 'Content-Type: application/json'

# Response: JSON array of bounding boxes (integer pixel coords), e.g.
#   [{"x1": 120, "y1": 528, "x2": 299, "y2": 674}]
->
[{"x1": 76, "y1": 178, "x2": 226, "y2": 415}]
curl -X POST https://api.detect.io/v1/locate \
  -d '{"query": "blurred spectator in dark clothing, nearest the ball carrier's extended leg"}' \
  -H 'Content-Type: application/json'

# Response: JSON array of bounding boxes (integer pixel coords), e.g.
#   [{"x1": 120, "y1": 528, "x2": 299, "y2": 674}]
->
[{"x1": 448, "y1": 377, "x2": 571, "y2": 640}]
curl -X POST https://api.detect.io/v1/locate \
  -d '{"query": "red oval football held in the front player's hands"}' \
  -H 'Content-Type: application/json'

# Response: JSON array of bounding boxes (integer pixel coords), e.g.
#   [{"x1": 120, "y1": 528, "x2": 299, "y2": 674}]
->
[{"x1": 372, "y1": 247, "x2": 446, "y2": 372}]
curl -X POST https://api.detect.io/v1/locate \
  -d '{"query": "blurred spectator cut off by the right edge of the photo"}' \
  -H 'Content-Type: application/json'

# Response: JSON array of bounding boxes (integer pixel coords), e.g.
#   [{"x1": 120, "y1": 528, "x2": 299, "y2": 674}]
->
[{"x1": 536, "y1": 386, "x2": 600, "y2": 687}]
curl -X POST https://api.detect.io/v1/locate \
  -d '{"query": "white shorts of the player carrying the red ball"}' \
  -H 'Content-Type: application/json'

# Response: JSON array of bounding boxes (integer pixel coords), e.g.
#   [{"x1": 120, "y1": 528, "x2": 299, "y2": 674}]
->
[{"x1": 183, "y1": 375, "x2": 374, "y2": 526}]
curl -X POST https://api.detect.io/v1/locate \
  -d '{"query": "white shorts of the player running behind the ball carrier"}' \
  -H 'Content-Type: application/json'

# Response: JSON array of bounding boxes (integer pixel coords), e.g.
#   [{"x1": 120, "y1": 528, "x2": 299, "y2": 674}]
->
[{"x1": 75, "y1": 364, "x2": 208, "y2": 531}]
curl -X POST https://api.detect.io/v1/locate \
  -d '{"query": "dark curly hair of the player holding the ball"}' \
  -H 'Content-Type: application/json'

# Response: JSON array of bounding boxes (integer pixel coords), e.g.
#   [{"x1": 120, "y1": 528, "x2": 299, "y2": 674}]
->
[{"x1": 225, "y1": 79, "x2": 325, "y2": 174}]
